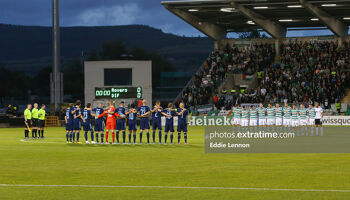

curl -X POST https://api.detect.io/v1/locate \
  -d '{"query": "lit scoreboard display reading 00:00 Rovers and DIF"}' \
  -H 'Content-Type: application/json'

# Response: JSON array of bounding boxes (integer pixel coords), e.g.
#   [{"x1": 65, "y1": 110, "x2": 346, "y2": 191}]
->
[{"x1": 95, "y1": 87, "x2": 142, "y2": 99}]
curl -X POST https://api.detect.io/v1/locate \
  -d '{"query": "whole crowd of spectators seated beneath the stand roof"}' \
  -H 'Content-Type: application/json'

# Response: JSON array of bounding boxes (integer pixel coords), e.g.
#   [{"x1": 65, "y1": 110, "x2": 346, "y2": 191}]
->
[{"x1": 181, "y1": 41, "x2": 350, "y2": 108}]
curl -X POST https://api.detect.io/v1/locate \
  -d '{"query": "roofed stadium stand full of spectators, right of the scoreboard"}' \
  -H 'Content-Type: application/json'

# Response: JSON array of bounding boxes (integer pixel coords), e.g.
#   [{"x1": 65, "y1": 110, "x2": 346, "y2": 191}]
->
[{"x1": 162, "y1": 0, "x2": 350, "y2": 114}]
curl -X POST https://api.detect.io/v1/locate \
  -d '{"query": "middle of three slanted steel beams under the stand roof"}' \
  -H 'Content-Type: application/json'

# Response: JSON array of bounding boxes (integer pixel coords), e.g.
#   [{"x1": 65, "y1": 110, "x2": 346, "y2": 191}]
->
[{"x1": 231, "y1": 2, "x2": 287, "y2": 39}]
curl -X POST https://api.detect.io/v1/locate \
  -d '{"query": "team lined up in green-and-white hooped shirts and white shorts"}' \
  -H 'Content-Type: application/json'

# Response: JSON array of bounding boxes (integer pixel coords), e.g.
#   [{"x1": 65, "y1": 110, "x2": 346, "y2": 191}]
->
[{"x1": 232, "y1": 103, "x2": 323, "y2": 135}]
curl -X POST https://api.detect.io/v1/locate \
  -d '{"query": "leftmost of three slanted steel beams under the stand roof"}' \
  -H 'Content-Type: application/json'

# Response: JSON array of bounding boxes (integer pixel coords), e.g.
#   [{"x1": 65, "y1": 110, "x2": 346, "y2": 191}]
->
[{"x1": 163, "y1": 4, "x2": 227, "y2": 41}]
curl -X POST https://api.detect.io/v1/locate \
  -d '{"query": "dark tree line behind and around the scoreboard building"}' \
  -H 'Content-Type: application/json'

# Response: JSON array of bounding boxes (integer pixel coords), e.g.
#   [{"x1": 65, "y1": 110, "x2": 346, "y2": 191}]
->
[{"x1": 0, "y1": 41, "x2": 173, "y2": 104}]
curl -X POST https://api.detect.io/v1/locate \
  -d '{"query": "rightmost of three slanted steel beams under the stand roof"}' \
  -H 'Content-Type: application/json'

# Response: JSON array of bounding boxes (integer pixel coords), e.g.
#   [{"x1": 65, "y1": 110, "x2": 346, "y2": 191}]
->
[{"x1": 299, "y1": 0, "x2": 348, "y2": 38}]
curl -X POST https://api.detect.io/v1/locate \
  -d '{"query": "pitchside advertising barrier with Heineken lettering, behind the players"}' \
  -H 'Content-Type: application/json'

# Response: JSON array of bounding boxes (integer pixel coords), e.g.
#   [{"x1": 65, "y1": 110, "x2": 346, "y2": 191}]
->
[{"x1": 186, "y1": 116, "x2": 350, "y2": 126}]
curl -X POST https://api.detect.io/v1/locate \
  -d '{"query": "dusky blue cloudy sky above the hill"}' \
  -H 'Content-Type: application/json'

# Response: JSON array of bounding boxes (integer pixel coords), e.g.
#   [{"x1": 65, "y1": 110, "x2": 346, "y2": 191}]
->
[{"x1": 0, "y1": 0, "x2": 338, "y2": 37}]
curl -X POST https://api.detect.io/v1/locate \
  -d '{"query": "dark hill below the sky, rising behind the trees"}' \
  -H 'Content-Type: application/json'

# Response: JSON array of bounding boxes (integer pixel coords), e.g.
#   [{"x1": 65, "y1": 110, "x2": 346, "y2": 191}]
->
[{"x1": 0, "y1": 24, "x2": 213, "y2": 74}]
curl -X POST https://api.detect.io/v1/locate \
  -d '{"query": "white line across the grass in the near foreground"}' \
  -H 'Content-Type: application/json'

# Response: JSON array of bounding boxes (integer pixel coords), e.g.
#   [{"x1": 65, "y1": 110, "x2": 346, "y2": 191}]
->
[{"x1": 0, "y1": 184, "x2": 350, "y2": 192}]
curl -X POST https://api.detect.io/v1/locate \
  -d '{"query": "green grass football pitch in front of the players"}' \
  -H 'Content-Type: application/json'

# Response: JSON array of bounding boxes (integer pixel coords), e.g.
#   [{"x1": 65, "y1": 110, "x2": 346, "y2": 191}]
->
[{"x1": 0, "y1": 127, "x2": 350, "y2": 200}]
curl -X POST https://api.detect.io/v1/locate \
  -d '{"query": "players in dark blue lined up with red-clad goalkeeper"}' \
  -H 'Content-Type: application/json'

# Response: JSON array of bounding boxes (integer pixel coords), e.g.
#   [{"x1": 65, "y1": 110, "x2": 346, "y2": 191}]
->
[{"x1": 65, "y1": 100, "x2": 189, "y2": 144}]
